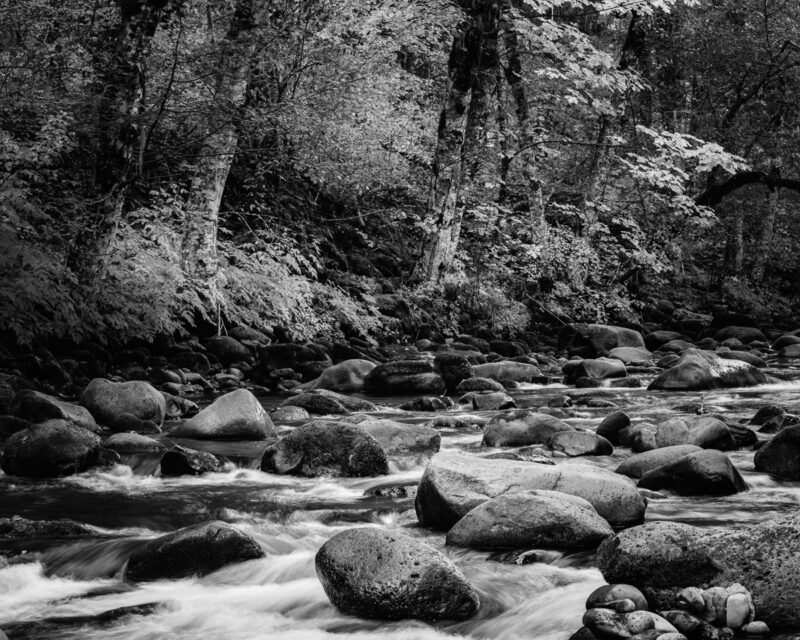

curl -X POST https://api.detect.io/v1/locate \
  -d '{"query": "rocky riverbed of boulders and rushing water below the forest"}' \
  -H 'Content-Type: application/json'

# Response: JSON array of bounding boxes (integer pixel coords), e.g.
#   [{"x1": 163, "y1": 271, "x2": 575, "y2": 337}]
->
[{"x1": 0, "y1": 327, "x2": 800, "y2": 640}]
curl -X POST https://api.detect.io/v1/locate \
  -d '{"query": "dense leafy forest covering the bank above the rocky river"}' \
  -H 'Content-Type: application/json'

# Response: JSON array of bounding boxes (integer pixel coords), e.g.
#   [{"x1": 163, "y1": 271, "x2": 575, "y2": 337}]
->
[{"x1": 0, "y1": 0, "x2": 800, "y2": 344}]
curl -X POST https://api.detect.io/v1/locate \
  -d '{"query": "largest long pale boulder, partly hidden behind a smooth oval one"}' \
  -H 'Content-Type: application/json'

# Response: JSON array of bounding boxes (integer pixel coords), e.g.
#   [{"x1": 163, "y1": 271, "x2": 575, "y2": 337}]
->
[{"x1": 415, "y1": 453, "x2": 645, "y2": 529}]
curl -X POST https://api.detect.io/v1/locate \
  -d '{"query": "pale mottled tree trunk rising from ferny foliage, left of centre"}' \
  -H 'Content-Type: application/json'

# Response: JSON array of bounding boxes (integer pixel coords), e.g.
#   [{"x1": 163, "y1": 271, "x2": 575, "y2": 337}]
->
[{"x1": 181, "y1": 0, "x2": 255, "y2": 284}]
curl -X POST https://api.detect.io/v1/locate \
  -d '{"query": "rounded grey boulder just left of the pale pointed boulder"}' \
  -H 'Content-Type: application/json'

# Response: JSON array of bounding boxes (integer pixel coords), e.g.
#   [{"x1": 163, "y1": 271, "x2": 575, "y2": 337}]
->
[{"x1": 80, "y1": 378, "x2": 166, "y2": 426}]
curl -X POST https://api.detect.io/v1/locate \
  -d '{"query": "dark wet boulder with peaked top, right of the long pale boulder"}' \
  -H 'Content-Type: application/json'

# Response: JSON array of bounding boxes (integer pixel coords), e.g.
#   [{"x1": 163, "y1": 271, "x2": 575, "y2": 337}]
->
[{"x1": 639, "y1": 449, "x2": 747, "y2": 496}]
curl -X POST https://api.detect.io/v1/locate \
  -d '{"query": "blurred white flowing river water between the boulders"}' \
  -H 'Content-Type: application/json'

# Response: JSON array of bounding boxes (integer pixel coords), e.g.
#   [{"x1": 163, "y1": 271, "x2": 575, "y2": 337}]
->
[{"x1": 0, "y1": 382, "x2": 800, "y2": 640}]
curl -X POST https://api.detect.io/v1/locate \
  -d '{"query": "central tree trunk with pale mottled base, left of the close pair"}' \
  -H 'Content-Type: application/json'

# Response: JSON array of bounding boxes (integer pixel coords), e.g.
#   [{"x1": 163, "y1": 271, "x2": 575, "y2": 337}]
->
[{"x1": 414, "y1": 20, "x2": 480, "y2": 282}]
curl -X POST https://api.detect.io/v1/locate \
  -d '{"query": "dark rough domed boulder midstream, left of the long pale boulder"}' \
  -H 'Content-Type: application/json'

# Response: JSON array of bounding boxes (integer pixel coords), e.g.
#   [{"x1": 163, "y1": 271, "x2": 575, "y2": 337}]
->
[{"x1": 261, "y1": 420, "x2": 389, "y2": 477}]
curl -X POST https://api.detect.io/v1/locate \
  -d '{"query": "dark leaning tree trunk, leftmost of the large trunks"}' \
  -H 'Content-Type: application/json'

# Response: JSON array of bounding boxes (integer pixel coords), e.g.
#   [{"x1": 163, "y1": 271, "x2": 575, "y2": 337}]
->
[{"x1": 69, "y1": 0, "x2": 180, "y2": 281}]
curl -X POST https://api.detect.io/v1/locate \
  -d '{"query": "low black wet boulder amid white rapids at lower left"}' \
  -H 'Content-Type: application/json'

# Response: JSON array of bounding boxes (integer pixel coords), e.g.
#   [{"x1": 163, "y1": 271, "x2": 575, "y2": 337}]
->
[{"x1": 125, "y1": 521, "x2": 264, "y2": 582}]
